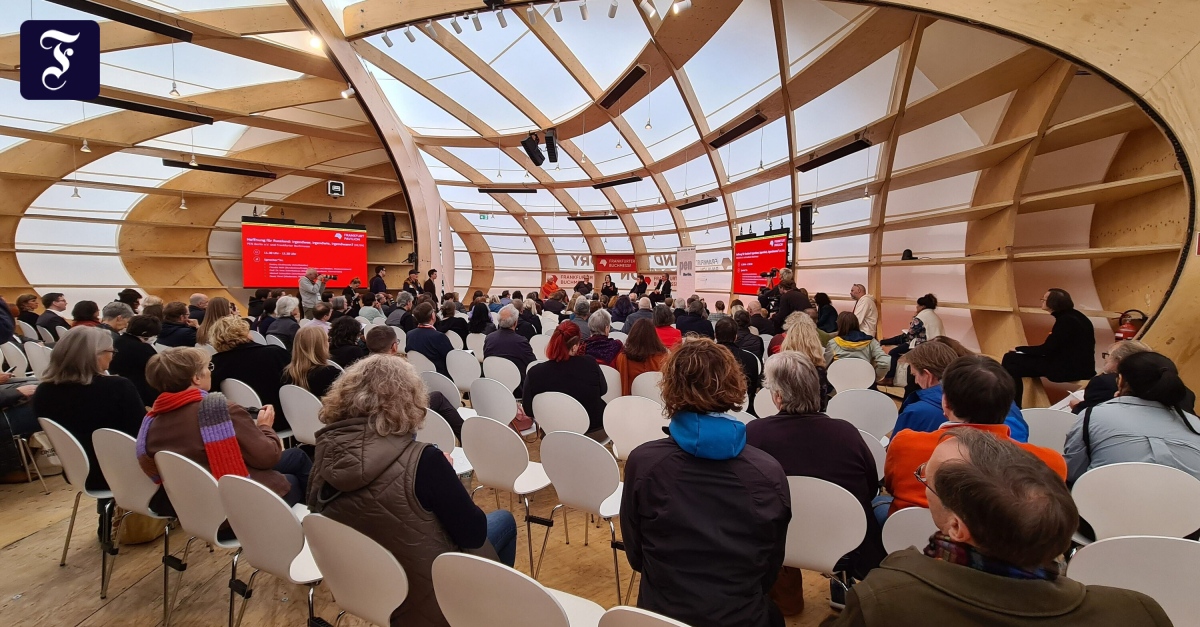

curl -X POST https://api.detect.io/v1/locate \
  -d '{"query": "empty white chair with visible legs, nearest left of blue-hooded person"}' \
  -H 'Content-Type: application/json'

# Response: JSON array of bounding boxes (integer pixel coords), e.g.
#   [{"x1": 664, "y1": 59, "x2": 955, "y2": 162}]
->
[{"x1": 534, "y1": 432, "x2": 624, "y2": 604}]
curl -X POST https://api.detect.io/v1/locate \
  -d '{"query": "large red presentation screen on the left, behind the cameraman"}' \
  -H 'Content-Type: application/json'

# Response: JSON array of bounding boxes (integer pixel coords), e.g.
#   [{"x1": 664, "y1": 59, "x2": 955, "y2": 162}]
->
[{"x1": 241, "y1": 219, "x2": 367, "y2": 289}]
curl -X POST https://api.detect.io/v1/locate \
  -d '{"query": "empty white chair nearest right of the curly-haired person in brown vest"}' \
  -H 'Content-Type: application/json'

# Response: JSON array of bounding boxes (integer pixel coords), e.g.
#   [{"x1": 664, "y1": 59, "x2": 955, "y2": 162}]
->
[{"x1": 462, "y1": 415, "x2": 550, "y2": 576}]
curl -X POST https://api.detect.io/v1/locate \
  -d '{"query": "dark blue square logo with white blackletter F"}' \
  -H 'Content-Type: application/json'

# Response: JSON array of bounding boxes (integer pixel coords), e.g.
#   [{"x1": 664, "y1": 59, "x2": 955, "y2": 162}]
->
[{"x1": 20, "y1": 19, "x2": 100, "y2": 100}]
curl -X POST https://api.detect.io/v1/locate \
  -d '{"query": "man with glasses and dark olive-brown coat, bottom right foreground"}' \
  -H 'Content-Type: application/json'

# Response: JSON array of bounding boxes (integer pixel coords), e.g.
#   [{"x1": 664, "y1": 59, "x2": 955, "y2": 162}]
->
[{"x1": 830, "y1": 429, "x2": 1171, "y2": 627}]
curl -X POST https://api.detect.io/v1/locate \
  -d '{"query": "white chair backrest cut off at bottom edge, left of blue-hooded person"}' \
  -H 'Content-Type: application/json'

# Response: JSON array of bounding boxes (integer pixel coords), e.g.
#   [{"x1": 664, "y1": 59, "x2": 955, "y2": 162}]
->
[{"x1": 434, "y1": 553, "x2": 570, "y2": 627}]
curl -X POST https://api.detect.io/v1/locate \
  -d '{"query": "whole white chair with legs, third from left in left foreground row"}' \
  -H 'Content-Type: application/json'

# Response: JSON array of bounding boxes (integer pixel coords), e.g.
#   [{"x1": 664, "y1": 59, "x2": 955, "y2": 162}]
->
[{"x1": 154, "y1": 450, "x2": 245, "y2": 625}]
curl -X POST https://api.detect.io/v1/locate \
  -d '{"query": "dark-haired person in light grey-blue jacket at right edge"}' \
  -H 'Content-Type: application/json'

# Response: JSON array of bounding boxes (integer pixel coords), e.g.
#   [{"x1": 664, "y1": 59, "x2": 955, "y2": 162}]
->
[{"x1": 1065, "y1": 348, "x2": 1200, "y2": 483}]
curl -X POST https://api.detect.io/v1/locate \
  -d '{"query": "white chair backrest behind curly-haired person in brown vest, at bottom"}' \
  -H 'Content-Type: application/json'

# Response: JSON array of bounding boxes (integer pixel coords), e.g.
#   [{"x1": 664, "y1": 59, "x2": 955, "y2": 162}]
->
[{"x1": 300, "y1": 514, "x2": 408, "y2": 625}]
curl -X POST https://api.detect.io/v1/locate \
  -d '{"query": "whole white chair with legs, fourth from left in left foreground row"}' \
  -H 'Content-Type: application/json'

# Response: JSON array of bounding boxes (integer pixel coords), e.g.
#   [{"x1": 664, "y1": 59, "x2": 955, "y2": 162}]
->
[{"x1": 217, "y1": 474, "x2": 320, "y2": 627}]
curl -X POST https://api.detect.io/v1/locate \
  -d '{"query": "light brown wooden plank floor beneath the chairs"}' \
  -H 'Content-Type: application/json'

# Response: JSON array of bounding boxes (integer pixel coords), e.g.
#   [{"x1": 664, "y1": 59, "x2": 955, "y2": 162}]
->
[{"x1": 0, "y1": 443, "x2": 830, "y2": 627}]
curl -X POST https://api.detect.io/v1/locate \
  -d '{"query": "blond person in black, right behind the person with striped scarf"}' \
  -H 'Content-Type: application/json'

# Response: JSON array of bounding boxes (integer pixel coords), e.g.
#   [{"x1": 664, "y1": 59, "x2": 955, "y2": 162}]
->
[{"x1": 209, "y1": 317, "x2": 296, "y2": 431}]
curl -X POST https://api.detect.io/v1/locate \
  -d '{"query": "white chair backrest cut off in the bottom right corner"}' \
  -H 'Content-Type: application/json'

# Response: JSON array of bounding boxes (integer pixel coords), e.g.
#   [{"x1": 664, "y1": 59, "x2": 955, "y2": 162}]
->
[{"x1": 1067, "y1": 536, "x2": 1200, "y2": 626}]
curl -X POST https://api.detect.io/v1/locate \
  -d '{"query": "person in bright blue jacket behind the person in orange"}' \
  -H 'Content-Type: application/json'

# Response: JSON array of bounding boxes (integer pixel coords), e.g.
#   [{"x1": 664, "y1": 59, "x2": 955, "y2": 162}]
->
[{"x1": 892, "y1": 342, "x2": 1030, "y2": 442}]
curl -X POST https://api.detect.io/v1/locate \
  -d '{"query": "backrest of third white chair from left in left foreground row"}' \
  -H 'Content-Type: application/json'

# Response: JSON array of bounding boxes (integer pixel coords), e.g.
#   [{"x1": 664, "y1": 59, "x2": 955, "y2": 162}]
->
[{"x1": 154, "y1": 450, "x2": 229, "y2": 547}]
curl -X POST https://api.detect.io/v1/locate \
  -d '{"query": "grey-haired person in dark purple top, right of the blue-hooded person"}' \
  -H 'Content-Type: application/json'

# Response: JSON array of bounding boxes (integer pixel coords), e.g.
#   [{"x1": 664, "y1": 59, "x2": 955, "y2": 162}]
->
[{"x1": 746, "y1": 351, "x2": 887, "y2": 595}]
